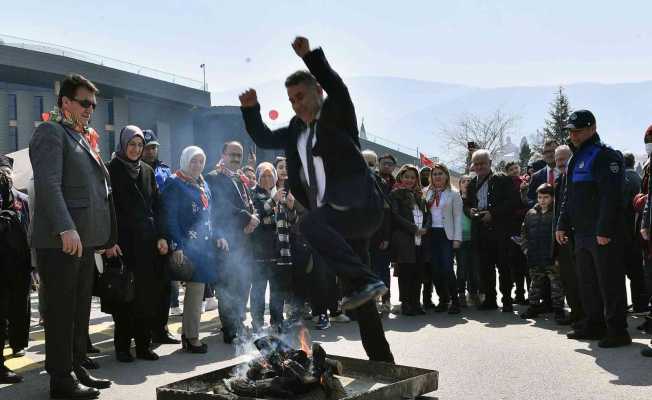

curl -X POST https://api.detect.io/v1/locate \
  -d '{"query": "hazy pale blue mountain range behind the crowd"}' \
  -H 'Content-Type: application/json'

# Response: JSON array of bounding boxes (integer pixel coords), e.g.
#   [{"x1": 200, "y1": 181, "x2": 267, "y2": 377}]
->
[{"x1": 212, "y1": 76, "x2": 652, "y2": 166}]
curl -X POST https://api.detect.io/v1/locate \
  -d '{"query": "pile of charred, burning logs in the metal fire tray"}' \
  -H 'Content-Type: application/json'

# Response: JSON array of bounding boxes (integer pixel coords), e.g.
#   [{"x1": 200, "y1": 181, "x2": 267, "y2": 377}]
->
[{"x1": 214, "y1": 328, "x2": 346, "y2": 400}]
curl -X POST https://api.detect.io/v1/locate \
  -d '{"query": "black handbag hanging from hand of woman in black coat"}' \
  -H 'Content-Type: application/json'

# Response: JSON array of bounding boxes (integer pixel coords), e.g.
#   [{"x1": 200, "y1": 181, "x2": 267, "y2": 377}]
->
[{"x1": 99, "y1": 256, "x2": 136, "y2": 304}]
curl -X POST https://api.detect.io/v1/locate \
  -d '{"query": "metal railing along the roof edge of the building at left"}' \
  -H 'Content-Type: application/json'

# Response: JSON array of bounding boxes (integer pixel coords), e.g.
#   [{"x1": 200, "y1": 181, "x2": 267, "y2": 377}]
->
[{"x1": 0, "y1": 34, "x2": 208, "y2": 91}]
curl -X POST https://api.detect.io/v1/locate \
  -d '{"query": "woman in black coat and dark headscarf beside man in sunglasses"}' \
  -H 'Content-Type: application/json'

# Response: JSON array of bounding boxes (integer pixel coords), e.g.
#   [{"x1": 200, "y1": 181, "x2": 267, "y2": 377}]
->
[{"x1": 102, "y1": 125, "x2": 168, "y2": 362}]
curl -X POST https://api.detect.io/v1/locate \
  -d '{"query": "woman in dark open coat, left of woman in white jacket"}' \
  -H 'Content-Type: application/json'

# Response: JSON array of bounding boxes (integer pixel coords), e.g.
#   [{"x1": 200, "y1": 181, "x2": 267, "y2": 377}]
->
[{"x1": 389, "y1": 165, "x2": 430, "y2": 316}]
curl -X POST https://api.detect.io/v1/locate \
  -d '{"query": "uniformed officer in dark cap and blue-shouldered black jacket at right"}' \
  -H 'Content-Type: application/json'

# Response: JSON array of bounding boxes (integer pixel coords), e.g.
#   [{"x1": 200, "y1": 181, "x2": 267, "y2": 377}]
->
[{"x1": 556, "y1": 110, "x2": 632, "y2": 348}]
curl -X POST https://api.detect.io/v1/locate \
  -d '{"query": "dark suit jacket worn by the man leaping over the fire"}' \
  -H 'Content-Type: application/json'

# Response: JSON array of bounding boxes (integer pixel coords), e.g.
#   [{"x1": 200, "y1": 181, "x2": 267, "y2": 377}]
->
[{"x1": 242, "y1": 49, "x2": 380, "y2": 209}]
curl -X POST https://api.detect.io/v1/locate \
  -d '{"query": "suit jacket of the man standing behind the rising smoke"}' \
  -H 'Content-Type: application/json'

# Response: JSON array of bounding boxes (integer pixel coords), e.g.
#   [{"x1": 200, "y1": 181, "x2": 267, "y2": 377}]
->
[{"x1": 205, "y1": 171, "x2": 254, "y2": 247}]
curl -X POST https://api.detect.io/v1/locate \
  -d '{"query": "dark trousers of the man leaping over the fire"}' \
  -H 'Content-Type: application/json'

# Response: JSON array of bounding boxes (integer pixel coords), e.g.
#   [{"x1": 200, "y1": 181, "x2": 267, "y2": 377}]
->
[{"x1": 300, "y1": 205, "x2": 394, "y2": 362}]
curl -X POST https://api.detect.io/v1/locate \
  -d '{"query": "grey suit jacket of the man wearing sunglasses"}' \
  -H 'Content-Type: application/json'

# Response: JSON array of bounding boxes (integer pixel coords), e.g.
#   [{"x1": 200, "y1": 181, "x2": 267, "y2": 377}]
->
[{"x1": 29, "y1": 122, "x2": 117, "y2": 248}]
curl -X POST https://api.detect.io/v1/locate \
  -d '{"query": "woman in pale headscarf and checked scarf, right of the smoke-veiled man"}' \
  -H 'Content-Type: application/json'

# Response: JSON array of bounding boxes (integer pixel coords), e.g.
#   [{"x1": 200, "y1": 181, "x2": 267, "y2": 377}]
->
[{"x1": 251, "y1": 162, "x2": 296, "y2": 331}]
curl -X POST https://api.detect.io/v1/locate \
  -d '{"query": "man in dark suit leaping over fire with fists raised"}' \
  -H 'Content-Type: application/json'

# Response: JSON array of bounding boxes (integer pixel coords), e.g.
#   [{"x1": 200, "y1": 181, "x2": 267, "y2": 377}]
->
[{"x1": 240, "y1": 37, "x2": 393, "y2": 362}]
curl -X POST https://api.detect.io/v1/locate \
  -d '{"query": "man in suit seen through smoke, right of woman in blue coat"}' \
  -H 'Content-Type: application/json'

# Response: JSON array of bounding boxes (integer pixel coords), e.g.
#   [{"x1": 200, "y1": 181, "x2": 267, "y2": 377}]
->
[{"x1": 206, "y1": 141, "x2": 260, "y2": 343}]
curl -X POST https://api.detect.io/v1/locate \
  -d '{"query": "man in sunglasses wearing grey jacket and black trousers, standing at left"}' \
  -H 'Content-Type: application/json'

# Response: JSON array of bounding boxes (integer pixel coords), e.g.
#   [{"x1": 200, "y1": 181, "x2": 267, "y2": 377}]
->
[{"x1": 29, "y1": 74, "x2": 120, "y2": 399}]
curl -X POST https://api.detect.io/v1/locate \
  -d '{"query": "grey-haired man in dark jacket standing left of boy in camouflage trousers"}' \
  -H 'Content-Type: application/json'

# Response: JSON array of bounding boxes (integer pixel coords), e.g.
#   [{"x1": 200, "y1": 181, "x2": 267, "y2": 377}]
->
[{"x1": 464, "y1": 149, "x2": 520, "y2": 312}]
